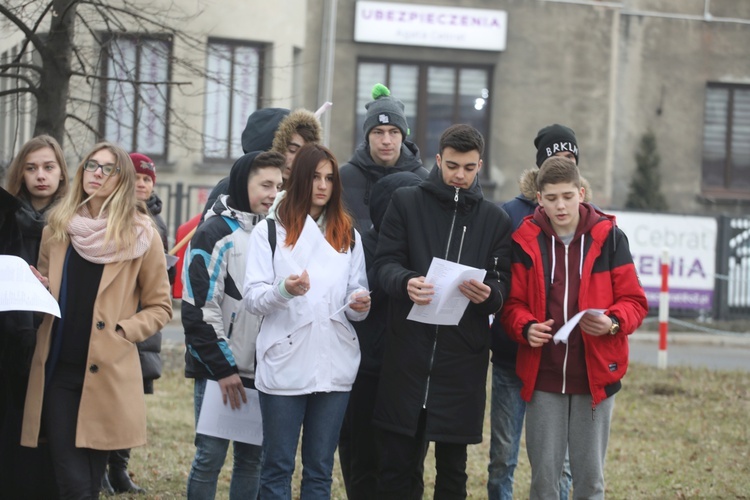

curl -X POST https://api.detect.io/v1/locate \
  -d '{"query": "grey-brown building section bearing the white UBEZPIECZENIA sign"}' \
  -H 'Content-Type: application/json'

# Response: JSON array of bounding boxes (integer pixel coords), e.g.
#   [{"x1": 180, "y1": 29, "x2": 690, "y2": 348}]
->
[{"x1": 304, "y1": 0, "x2": 750, "y2": 214}]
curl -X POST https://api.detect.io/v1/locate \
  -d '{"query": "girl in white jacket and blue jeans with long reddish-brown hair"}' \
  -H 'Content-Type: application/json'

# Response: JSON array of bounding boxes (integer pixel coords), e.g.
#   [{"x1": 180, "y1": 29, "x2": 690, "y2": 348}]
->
[{"x1": 243, "y1": 144, "x2": 370, "y2": 499}]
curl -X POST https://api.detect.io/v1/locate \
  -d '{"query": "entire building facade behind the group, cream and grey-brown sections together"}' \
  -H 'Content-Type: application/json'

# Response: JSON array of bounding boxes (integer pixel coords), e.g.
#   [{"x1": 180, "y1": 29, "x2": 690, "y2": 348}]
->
[{"x1": 0, "y1": 0, "x2": 750, "y2": 233}]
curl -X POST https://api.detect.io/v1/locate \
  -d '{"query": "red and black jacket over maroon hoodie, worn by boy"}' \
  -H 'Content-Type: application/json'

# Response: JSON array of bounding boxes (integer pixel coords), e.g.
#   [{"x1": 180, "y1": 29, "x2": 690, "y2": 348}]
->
[{"x1": 500, "y1": 203, "x2": 648, "y2": 406}]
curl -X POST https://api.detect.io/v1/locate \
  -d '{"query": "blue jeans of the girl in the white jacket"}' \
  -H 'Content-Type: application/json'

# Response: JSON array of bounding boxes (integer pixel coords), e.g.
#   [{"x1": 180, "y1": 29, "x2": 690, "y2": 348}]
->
[{"x1": 258, "y1": 392, "x2": 349, "y2": 500}]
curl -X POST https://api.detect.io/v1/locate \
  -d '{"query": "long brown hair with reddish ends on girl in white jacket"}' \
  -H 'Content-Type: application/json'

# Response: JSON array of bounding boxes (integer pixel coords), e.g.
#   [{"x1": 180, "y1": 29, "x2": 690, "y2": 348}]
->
[{"x1": 276, "y1": 144, "x2": 353, "y2": 251}]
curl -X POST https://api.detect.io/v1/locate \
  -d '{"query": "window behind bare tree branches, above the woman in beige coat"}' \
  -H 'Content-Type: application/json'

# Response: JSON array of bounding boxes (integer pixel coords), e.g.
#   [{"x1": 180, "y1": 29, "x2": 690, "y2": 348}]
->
[{"x1": 100, "y1": 36, "x2": 172, "y2": 158}]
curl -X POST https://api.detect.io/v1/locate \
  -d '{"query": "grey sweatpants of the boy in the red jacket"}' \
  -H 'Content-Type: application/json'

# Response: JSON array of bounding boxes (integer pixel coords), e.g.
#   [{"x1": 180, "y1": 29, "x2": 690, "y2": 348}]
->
[{"x1": 526, "y1": 391, "x2": 615, "y2": 500}]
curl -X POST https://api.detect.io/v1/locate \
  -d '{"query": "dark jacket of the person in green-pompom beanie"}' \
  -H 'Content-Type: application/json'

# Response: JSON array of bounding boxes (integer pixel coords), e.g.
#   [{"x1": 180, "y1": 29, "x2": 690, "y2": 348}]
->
[{"x1": 339, "y1": 141, "x2": 428, "y2": 233}]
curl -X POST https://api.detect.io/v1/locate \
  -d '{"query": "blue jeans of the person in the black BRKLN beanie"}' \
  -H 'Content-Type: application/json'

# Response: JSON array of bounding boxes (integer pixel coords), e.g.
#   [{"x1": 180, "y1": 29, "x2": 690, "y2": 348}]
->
[{"x1": 487, "y1": 363, "x2": 573, "y2": 500}]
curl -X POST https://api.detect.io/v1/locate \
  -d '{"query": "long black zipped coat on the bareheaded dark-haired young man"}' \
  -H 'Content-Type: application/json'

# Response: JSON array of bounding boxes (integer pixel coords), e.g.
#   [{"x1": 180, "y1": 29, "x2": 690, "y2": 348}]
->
[{"x1": 373, "y1": 167, "x2": 511, "y2": 444}]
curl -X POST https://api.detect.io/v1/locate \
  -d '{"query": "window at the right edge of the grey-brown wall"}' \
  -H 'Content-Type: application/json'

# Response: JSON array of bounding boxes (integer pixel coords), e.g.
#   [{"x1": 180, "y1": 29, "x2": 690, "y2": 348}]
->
[{"x1": 702, "y1": 83, "x2": 750, "y2": 199}]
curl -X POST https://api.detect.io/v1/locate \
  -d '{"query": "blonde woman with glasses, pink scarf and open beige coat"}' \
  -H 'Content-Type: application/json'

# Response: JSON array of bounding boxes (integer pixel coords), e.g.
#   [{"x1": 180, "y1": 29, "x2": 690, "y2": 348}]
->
[{"x1": 21, "y1": 143, "x2": 172, "y2": 498}]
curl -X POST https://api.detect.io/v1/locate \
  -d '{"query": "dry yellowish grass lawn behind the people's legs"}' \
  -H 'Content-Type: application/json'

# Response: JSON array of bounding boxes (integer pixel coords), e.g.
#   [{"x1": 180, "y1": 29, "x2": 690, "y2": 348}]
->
[{"x1": 119, "y1": 344, "x2": 750, "y2": 499}]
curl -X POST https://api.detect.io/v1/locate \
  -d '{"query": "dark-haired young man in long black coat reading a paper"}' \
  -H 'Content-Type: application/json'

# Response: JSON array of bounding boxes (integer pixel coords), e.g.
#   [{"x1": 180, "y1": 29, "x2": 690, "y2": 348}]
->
[{"x1": 373, "y1": 125, "x2": 512, "y2": 498}]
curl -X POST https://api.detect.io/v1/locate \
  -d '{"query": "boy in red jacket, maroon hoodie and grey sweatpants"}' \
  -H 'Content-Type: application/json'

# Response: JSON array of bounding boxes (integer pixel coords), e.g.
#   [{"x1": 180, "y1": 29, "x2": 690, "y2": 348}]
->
[{"x1": 501, "y1": 157, "x2": 648, "y2": 499}]
